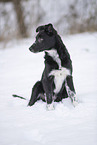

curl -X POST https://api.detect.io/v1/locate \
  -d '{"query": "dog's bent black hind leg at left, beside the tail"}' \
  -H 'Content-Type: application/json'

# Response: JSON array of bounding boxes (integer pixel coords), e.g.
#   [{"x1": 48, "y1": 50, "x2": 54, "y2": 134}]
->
[{"x1": 28, "y1": 81, "x2": 44, "y2": 106}]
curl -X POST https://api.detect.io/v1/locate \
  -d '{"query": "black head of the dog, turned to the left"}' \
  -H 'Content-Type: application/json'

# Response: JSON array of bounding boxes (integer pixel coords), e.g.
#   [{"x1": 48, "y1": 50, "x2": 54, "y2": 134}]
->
[{"x1": 29, "y1": 24, "x2": 56, "y2": 53}]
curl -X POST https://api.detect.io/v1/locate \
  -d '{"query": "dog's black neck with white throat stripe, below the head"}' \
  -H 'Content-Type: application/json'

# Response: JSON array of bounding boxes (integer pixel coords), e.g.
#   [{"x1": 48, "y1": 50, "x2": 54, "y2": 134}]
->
[{"x1": 45, "y1": 35, "x2": 71, "y2": 69}]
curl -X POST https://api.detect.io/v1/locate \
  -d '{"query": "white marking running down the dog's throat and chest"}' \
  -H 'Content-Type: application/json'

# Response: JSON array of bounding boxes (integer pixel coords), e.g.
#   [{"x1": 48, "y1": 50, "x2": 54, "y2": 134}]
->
[{"x1": 47, "y1": 49, "x2": 70, "y2": 94}]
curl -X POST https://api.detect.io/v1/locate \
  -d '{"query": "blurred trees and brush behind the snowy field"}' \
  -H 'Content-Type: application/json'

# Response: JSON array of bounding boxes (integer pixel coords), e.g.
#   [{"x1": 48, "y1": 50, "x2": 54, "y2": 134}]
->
[{"x1": 0, "y1": 0, "x2": 97, "y2": 41}]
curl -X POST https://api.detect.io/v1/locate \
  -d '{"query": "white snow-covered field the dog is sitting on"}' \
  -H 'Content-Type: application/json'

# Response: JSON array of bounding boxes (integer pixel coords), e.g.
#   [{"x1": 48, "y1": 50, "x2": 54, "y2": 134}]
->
[{"x1": 0, "y1": 33, "x2": 97, "y2": 145}]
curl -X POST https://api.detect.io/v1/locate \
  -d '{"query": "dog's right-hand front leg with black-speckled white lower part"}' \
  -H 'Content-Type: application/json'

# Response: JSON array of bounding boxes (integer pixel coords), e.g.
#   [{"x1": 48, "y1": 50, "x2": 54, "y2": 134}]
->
[{"x1": 65, "y1": 76, "x2": 78, "y2": 107}]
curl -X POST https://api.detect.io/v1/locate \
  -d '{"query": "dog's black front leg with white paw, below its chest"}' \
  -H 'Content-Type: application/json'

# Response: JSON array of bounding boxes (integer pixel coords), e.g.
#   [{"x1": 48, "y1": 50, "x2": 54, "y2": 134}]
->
[{"x1": 42, "y1": 77, "x2": 54, "y2": 110}]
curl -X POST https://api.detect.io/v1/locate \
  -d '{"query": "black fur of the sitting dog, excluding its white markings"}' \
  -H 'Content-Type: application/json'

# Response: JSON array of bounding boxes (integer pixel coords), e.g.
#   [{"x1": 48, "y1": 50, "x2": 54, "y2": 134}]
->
[{"x1": 28, "y1": 24, "x2": 75, "y2": 106}]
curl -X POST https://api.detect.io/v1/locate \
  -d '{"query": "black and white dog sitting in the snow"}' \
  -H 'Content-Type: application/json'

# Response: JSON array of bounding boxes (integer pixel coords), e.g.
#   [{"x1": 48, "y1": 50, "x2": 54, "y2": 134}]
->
[{"x1": 28, "y1": 24, "x2": 78, "y2": 110}]
